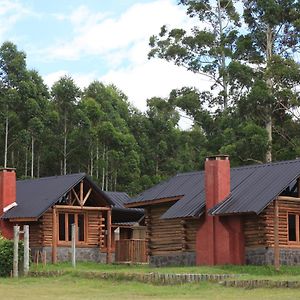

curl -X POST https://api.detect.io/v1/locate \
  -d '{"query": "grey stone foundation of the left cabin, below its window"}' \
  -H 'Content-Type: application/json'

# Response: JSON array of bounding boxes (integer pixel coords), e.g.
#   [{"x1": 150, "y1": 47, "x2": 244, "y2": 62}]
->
[{"x1": 31, "y1": 247, "x2": 115, "y2": 263}]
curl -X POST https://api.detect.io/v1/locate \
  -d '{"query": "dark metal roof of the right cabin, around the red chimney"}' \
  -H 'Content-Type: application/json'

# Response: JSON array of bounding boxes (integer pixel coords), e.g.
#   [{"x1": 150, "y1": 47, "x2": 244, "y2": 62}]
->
[{"x1": 129, "y1": 160, "x2": 300, "y2": 219}]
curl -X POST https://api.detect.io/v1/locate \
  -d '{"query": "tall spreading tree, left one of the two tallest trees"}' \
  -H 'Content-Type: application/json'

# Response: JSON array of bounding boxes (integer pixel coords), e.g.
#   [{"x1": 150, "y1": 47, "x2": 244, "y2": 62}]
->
[{"x1": 149, "y1": 0, "x2": 240, "y2": 109}]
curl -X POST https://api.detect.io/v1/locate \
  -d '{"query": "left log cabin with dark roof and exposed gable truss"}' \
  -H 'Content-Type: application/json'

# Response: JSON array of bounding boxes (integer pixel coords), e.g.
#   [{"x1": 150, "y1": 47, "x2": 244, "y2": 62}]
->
[{"x1": 0, "y1": 168, "x2": 143, "y2": 263}]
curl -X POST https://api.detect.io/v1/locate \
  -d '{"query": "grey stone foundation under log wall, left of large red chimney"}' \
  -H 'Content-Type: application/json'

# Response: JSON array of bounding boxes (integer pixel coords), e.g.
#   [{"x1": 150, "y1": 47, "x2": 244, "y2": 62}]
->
[{"x1": 149, "y1": 252, "x2": 196, "y2": 267}]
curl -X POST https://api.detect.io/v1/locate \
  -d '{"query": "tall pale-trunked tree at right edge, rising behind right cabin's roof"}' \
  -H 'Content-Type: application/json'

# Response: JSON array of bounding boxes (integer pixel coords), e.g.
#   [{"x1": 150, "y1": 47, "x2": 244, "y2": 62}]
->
[{"x1": 235, "y1": 0, "x2": 300, "y2": 161}]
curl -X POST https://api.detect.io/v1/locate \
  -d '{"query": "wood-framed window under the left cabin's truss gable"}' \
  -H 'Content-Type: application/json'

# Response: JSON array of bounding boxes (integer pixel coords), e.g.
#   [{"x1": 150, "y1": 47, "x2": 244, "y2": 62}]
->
[{"x1": 58, "y1": 213, "x2": 86, "y2": 243}]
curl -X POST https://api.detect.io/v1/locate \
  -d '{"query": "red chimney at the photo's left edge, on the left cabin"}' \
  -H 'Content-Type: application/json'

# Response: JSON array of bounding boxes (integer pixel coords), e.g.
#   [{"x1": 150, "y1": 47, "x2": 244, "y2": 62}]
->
[{"x1": 0, "y1": 168, "x2": 17, "y2": 238}]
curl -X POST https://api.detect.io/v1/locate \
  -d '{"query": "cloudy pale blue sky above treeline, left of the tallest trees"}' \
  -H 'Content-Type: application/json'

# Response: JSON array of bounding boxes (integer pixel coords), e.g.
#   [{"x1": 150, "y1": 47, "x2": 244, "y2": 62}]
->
[{"x1": 0, "y1": 0, "x2": 210, "y2": 117}]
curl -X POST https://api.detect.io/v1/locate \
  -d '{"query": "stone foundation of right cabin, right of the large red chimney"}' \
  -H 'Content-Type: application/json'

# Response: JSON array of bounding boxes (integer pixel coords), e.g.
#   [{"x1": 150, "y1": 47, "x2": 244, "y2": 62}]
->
[{"x1": 245, "y1": 248, "x2": 300, "y2": 266}]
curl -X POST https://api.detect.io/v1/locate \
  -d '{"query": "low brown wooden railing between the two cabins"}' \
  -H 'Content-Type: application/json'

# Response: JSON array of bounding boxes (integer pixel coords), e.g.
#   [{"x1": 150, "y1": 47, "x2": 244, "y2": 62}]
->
[{"x1": 115, "y1": 239, "x2": 148, "y2": 263}]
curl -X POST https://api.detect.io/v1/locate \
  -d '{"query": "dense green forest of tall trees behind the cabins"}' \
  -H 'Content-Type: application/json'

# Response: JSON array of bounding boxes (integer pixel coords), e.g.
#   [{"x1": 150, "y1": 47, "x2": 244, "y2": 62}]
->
[{"x1": 0, "y1": 0, "x2": 300, "y2": 195}]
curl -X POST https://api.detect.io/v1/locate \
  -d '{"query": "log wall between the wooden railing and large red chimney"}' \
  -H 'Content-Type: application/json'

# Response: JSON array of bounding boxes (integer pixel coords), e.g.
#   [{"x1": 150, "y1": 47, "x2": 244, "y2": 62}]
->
[{"x1": 145, "y1": 203, "x2": 200, "y2": 256}]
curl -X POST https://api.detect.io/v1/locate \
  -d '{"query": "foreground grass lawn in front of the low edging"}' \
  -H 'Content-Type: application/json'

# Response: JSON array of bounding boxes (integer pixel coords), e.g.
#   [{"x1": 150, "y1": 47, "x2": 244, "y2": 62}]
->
[{"x1": 0, "y1": 274, "x2": 300, "y2": 300}]
